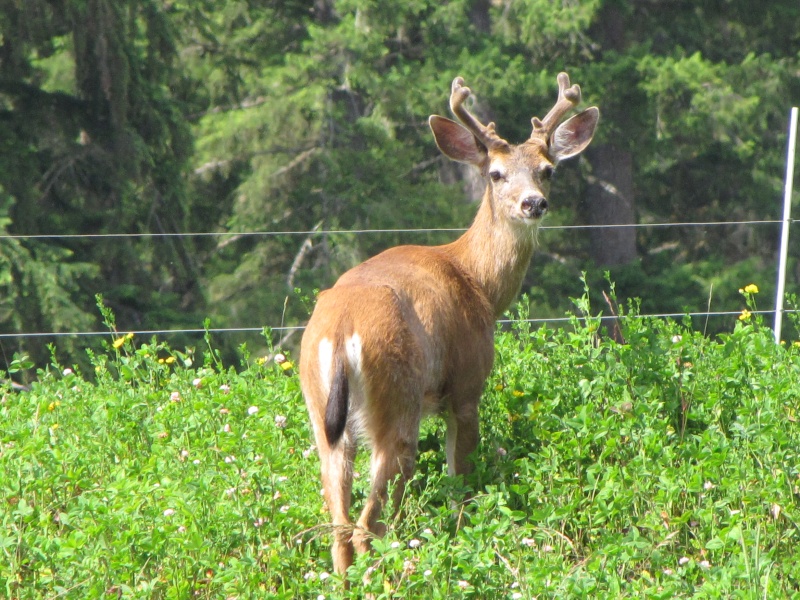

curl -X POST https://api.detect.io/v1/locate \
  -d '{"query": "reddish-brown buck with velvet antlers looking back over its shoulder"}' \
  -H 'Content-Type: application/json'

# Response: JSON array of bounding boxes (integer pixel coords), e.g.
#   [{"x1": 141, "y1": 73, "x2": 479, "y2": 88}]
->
[{"x1": 299, "y1": 73, "x2": 600, "y2": 575}]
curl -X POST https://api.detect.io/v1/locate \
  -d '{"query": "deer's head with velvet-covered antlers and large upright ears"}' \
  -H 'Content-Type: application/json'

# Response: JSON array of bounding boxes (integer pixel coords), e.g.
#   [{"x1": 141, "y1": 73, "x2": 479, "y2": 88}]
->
[{"x1": 428, "y1": 73, "x2": 600, "y2": 226}]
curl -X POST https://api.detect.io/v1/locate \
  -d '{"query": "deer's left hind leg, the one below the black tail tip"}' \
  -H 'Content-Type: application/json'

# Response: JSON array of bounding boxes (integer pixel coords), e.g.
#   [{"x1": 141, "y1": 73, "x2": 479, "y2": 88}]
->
[{"x1": 317, "y1": 432, "x2": 356, "y2": 575}]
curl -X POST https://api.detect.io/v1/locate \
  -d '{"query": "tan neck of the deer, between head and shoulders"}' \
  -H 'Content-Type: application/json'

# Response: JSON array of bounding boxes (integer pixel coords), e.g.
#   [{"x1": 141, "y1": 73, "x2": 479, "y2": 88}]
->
[{"x1": 446, "y1": 187, "x2": 538, "y2": 317}]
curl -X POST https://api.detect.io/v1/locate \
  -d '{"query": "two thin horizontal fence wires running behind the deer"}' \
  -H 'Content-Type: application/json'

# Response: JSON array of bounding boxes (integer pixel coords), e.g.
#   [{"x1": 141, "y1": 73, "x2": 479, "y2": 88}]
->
[{"x1": 0, "y1": 219, "x2": 798, "y2": 340}]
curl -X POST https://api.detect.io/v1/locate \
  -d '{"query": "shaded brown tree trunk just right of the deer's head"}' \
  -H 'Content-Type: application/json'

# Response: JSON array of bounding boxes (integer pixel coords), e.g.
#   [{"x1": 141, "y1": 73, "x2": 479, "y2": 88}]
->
[{"x1": 586, "y1": 144, "x2": 638, "y2": 267}]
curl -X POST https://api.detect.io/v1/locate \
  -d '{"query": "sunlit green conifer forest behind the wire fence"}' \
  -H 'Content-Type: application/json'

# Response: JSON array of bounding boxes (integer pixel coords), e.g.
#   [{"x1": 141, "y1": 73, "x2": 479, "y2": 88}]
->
[{"x1": 0, "y1": 0, "x2": 800, "y2": 368}]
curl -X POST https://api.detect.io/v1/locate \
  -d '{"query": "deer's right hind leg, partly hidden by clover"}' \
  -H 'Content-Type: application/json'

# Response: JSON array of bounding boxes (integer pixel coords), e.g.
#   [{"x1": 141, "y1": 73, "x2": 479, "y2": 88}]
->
[{"x1": 353, "y1": 400, "x2": 421, "y2": 552}]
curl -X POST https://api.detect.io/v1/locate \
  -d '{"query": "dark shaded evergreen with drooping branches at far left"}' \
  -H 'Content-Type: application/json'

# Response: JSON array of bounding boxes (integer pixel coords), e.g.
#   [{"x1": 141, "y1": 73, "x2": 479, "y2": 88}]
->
[{"x1": 0, "y1": 0, "x2": 197, "y2": 366}]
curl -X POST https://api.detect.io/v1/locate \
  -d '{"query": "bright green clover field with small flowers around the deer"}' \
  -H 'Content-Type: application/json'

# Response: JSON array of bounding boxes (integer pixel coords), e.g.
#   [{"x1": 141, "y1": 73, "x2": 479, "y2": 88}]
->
[{"x1": 0, "y1": 287, "x2": 800, "y2": 599}]
